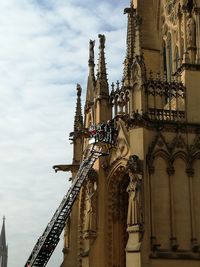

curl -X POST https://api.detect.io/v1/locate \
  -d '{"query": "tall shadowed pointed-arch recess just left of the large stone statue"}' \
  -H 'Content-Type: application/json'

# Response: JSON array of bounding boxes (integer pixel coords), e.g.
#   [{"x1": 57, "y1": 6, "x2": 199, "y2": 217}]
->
[{"x1": 106, "y1": 161, "x2": 129, "y2": 267}]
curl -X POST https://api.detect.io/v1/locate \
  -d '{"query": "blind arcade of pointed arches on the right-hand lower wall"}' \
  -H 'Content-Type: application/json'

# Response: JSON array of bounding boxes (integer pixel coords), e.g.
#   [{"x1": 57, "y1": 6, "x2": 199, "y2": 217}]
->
[{"x1": 147, "y1": 133, "x2": 200, "y2": 258}]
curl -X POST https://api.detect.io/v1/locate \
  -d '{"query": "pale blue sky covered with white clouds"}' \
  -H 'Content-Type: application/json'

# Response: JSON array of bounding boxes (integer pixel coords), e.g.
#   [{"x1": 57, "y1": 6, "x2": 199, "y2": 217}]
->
[{"x1": 0, "y1": 0, "x2": 129, "y2": 267}]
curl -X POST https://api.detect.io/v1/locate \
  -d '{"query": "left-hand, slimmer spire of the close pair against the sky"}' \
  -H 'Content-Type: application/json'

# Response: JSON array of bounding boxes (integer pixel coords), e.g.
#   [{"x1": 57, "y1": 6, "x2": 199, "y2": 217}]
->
[{"x1": 85, "y1": 40, "x2": 96, "y2": 110}]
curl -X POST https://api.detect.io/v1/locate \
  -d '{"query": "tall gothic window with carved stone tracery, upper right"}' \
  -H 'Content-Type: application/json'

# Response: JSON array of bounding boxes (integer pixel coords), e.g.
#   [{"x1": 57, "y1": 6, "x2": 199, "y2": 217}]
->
[{"x1": 161, "y1": 0, "x2": 200, "y2": 77}]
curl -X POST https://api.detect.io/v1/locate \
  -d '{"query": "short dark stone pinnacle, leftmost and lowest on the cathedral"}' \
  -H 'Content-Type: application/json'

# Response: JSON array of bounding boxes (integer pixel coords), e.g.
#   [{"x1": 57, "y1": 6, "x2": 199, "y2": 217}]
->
[{"x1": 74, "y1": 84, "x2": 83, "y2": 132}]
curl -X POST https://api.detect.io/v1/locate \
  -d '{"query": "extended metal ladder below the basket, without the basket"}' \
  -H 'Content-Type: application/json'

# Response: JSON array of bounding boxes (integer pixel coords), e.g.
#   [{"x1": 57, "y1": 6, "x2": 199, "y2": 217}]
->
[{"x1": 25, "y1": 146, "x2": 104, "y2": 267}]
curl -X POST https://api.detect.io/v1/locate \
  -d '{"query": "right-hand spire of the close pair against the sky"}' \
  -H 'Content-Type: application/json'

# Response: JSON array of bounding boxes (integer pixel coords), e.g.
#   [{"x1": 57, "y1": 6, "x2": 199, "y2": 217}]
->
[{"x1": 97, "y1": 34, "x2": 109, "y2": 96}]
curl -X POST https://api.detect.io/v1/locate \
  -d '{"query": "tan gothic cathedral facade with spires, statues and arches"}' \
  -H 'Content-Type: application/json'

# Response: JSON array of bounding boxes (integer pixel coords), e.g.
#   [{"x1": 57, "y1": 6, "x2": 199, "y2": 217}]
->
[{"x1": 61, "y1": 0, "x2": 200, "y2": 267}]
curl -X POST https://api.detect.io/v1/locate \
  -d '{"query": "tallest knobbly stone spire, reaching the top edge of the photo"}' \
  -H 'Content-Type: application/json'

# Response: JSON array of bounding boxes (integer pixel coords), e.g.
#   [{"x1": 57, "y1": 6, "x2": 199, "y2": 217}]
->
[{"x1": 123, "y1": 1, "x2": 136, "y2": 85}]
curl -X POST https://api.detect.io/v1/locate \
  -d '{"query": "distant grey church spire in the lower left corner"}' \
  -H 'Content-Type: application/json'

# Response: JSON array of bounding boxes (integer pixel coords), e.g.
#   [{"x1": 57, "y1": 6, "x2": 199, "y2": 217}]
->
[{"x1": 0, "y1": 217, "x2": 8, "y2": 267}]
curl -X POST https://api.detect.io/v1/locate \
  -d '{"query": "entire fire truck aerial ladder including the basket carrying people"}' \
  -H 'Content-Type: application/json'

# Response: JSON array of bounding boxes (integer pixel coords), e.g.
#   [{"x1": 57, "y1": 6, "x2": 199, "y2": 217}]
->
[{"x1": 24, "y1": 122, "x2": 117, "y2": 267}]
